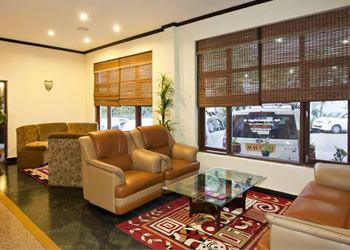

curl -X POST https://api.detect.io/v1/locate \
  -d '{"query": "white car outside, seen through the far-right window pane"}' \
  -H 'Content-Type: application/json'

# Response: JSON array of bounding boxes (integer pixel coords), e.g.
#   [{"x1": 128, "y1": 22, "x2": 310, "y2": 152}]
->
[{"x1": 312, "y1": 111, "x2": 348, "y2": 134}]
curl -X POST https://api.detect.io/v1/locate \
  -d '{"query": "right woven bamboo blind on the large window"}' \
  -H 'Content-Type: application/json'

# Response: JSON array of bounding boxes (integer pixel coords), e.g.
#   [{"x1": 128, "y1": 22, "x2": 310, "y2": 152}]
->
[{"x1": 261, "y1": 8, "x2": 350, "y2": 103}]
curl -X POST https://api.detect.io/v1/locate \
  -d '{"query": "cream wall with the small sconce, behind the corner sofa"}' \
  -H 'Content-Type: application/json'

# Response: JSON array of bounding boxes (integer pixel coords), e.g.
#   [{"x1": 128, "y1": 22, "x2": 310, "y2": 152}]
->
[{"x1": 0, "y1": 42, "x2": 86, "y2": 157}]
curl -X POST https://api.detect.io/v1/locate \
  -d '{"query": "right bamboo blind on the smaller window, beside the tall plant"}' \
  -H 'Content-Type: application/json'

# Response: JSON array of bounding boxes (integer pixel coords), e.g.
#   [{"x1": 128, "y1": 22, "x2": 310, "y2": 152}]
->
[{"x1": 120, "y1": 52, "x2": 152, "y2": 106}]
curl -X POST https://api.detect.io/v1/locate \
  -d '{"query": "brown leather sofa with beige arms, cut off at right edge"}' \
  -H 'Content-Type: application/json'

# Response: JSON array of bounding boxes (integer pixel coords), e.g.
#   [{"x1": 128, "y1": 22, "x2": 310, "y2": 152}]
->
[{"x1": 258, "y1": 163, "x2": 350, "y2": 250}]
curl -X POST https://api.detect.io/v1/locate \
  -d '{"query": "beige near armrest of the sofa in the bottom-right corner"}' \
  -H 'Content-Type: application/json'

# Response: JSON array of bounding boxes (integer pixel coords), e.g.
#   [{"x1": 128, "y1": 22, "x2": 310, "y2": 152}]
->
[{"x1": 266, "y1": 214, "x2": 350, "y2": 250}]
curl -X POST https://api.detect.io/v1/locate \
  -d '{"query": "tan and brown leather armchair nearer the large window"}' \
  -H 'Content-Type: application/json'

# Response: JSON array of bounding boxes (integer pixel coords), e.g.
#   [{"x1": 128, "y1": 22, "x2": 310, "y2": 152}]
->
[{"x1": 130, "y1": 125, "x2": 200, "y2": 186}]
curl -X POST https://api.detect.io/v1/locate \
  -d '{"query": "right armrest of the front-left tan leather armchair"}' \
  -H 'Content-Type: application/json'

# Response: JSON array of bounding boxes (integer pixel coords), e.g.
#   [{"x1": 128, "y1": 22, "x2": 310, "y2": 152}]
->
[{"x1": 131, "y1": 149, "x2": 162, "y2": 173}]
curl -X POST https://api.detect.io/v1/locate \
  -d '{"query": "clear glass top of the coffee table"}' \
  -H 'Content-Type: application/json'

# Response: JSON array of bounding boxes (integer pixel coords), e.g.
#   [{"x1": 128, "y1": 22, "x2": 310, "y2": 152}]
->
[{"x1": 164, "y1": 168, "x2": 266, "y2": 207}]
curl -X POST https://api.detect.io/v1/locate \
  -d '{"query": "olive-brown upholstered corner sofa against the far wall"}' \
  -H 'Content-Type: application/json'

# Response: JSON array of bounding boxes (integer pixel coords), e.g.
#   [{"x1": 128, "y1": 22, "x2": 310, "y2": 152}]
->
[{"x1": 16, "y1": 122, "x2": 98, "y2": 168}]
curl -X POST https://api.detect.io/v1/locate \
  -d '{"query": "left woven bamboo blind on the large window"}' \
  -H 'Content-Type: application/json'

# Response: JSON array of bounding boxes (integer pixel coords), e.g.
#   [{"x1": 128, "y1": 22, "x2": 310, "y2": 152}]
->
[{"x1": 197, "y1": 29, "x2": 259, "y2": 107}]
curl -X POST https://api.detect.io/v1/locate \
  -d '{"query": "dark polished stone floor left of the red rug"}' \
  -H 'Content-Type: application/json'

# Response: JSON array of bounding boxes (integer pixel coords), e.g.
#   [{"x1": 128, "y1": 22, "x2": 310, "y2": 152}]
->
[{"x1": 0, "y1": 165, "x2": 179, "y2": 249}]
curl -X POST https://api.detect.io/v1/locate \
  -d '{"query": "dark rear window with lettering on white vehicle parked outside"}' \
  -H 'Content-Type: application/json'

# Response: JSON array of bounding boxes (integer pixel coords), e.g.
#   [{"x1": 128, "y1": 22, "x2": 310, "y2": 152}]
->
[{"x1": 232, "y1": 112, "x2": 298, "y2": 140}]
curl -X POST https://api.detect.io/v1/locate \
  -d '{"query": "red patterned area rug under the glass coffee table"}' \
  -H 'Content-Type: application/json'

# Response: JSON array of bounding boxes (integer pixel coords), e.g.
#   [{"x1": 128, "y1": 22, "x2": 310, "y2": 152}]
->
[{"x1": 116, "y1": 191, "x2": 292, "y2": 250}]
